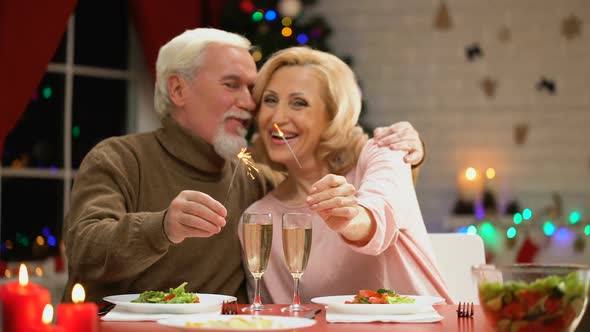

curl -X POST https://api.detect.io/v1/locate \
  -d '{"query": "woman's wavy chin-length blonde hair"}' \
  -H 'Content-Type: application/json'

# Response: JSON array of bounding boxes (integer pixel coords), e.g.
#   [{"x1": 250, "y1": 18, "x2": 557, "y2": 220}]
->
[{"x1": 252, "y1": 47, "x2": 368, "y2": 175}]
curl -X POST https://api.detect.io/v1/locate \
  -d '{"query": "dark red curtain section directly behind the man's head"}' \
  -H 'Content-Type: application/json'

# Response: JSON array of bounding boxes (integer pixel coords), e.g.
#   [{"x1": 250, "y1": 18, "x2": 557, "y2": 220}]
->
[{"x1": 130, "y1": 0, "x2": 225, "y2": 78}]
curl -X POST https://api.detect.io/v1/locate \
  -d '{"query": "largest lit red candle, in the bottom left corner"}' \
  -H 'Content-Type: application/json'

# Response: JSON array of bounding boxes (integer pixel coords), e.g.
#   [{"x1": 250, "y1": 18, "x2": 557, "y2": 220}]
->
[{"x1": 0, "y1": 264, "x2": 51, "y2": 332}]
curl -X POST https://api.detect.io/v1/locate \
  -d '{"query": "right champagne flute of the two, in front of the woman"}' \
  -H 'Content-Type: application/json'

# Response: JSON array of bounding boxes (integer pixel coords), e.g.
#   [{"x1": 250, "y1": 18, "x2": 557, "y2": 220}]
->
[{"x1": 281, "y1": 213, "x2": 312, "y2": 312}]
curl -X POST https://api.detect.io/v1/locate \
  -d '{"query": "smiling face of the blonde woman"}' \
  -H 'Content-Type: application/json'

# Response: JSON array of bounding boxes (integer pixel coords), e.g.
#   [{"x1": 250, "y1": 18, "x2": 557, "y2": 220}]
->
[{"x1": 258, "y1": 65, "x2": 329, "y2": 168}]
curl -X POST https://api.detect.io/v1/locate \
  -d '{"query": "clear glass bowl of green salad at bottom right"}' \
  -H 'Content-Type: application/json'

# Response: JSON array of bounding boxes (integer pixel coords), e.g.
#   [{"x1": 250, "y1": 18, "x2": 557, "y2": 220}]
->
[{"x1": 471, "y1": 264, "x2": 590, "y2": 332}]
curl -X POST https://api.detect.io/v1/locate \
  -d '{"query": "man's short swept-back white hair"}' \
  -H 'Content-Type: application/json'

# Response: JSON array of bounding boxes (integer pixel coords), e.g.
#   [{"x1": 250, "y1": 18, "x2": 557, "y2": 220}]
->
[{"x1": 154, "y1": 28, "x2": 251, "y2": 118}]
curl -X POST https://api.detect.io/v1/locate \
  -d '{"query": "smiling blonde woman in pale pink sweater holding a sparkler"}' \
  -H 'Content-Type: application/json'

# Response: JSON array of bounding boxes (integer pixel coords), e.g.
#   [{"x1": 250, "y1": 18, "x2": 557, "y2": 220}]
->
[{"x1": 240, "y1": 47, "x2": 452, "y2": 303}]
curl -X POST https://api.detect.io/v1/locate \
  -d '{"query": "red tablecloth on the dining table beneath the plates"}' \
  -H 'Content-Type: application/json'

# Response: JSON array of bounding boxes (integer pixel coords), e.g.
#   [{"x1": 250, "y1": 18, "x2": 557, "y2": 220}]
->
[{"x1": 100, "y1": 304, "x2": 494, "y2": 332}]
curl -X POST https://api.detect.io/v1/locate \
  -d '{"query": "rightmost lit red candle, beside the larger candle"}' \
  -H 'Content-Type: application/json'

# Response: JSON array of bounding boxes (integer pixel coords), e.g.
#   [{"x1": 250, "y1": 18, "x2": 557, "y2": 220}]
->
[{"x1": 57, "y1": 284, "x2": 98, "y2": 332}]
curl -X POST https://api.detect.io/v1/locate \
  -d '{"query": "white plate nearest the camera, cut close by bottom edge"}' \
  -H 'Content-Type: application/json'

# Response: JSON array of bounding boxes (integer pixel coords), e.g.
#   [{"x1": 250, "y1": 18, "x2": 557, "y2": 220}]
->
[{"x1": 158, "y1": 315, "x2": 316, "y2": 331}]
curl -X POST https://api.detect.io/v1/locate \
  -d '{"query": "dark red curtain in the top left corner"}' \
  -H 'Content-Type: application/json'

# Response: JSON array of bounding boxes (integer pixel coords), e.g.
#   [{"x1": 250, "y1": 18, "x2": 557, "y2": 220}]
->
[{"x1": 0, "y1": 0, "x2": 76, "y2": 160}]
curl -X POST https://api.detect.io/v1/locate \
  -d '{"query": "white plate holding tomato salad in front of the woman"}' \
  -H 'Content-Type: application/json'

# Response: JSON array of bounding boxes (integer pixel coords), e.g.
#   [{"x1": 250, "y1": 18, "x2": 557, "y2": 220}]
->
[{"x1": 311, "y1": 295, "x2": 445, "y2": 315}]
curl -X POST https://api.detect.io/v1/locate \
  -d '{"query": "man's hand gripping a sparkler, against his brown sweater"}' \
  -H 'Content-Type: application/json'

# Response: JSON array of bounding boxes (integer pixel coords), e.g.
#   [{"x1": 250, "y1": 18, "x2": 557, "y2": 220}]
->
[{"x1": 164, "y1": 190, "x2": 227, "y2": 243}]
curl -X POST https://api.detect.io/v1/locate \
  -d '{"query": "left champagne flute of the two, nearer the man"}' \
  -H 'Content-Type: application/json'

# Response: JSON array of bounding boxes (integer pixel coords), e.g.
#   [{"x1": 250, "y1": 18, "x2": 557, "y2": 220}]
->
[{"x1": 242, "y1": 213, "x2": 272, "y2": 312}]
